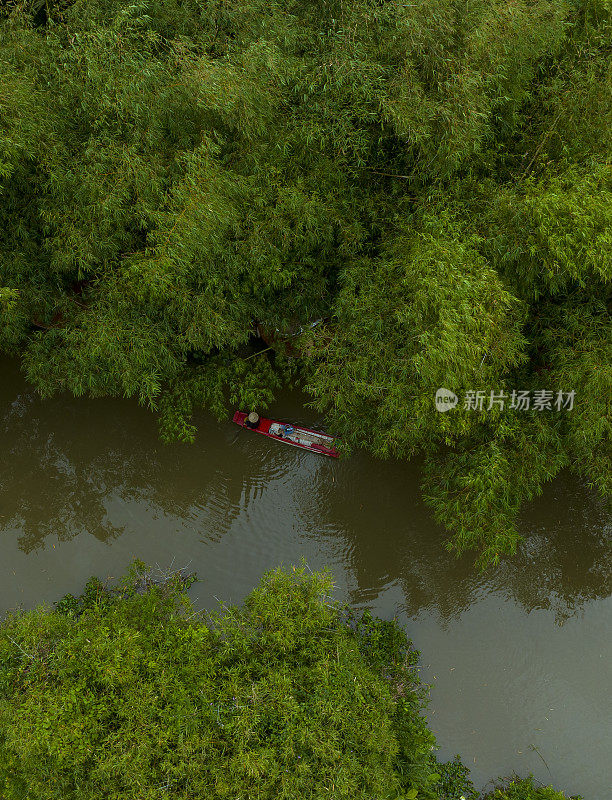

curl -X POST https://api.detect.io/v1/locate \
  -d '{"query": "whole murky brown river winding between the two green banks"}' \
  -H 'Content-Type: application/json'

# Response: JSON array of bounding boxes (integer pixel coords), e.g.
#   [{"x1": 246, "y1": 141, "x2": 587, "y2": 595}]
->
[{"x1": 0, "y1": 361, "x2": 612, "y2": 800}]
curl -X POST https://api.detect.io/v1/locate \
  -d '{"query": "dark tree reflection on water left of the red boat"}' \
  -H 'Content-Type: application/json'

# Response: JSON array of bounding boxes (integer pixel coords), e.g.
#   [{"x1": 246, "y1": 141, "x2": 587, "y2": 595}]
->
[{"x1": 0, "y1": 368, "x2": 253, "y2": 552}]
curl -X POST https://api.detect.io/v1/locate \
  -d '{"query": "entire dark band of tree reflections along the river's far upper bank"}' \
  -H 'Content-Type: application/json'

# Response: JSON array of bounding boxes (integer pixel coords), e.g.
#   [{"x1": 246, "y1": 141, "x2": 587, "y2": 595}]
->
[{"x1": 0, "y1": 361, "x2": 612, "y2": 624}]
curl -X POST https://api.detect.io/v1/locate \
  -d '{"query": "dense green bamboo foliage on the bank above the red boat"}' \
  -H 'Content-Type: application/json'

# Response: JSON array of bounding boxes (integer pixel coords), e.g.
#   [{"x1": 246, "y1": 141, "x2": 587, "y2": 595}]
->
[{"x1": 0, "y1": 0, "x2": 612, "y2": 561}]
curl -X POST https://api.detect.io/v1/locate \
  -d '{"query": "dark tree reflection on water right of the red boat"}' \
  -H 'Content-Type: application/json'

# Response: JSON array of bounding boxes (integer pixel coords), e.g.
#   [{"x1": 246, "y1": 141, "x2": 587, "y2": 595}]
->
[{"x1": 317, "y1": 457, "x2": 612, "y2": 623}]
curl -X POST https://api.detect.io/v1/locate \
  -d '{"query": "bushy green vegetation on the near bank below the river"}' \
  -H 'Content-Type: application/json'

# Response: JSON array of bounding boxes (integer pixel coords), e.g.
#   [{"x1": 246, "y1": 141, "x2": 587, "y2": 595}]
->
[{"x1": 0, "y1": 564, "x2": 580, "y2": 800}]
